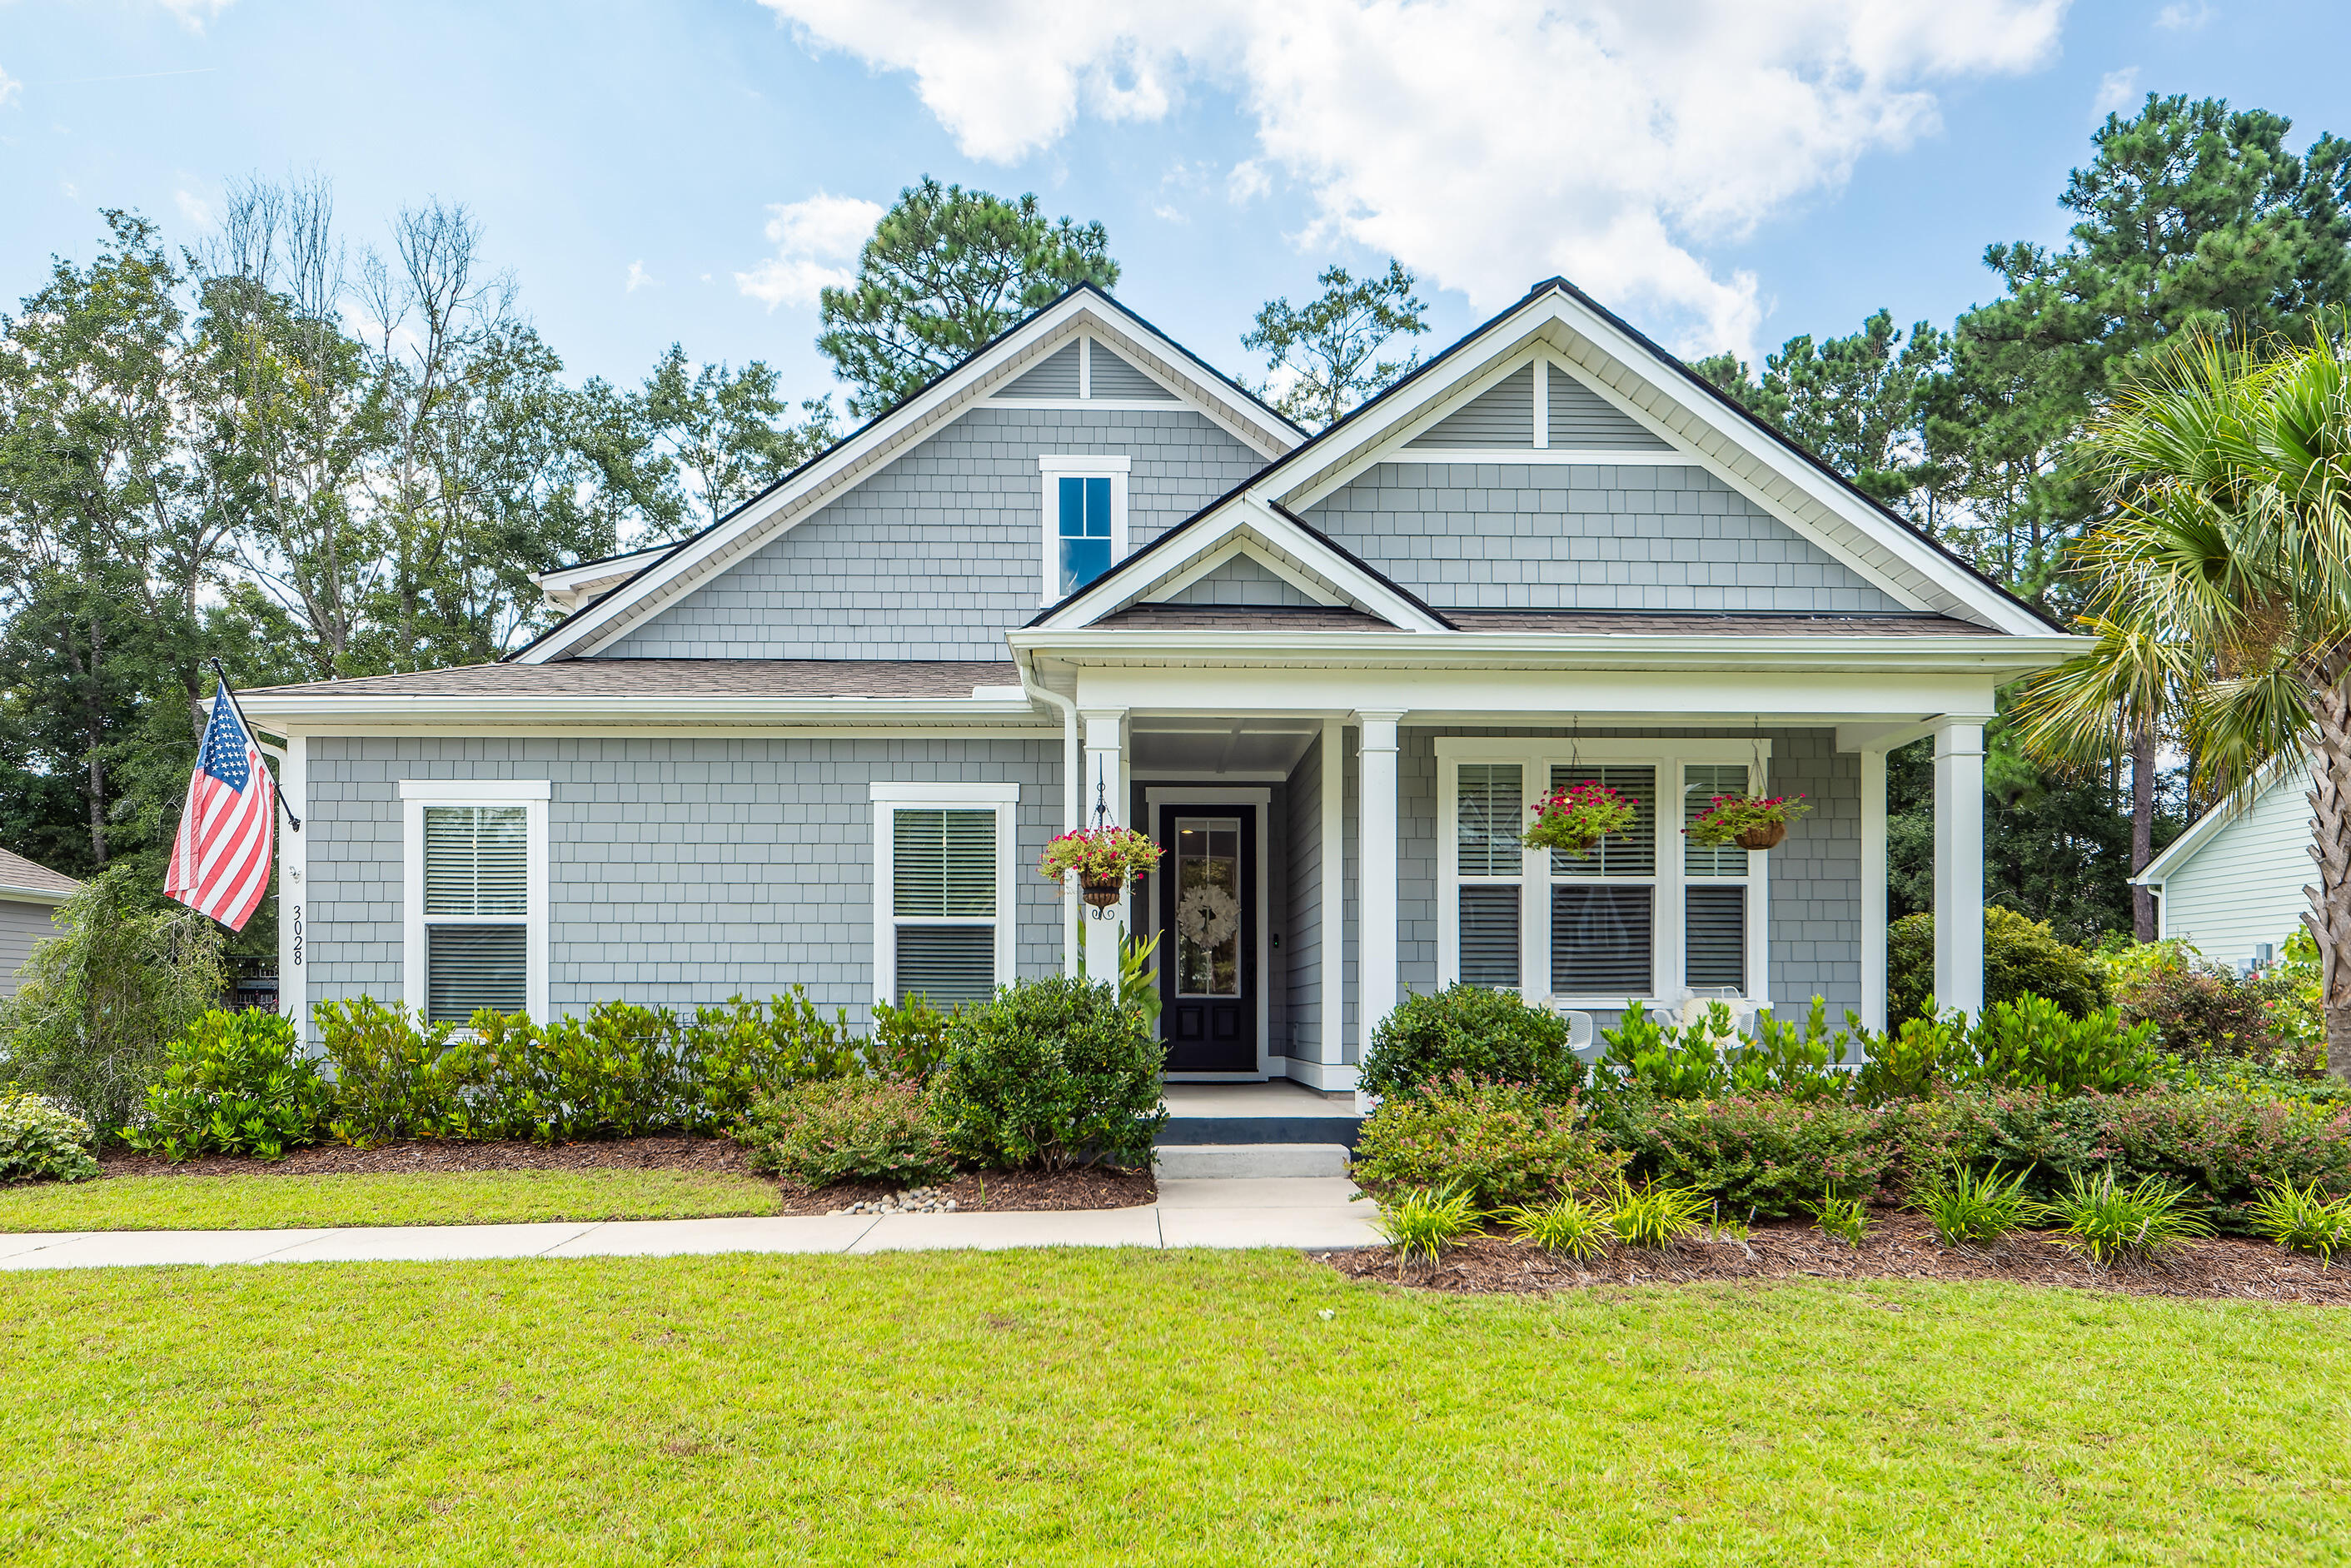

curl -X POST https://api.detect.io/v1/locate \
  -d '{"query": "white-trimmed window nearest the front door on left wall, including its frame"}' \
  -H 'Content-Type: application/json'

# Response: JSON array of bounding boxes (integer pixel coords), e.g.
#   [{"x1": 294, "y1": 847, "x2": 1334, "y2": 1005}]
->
[{"x1": 872, "y1": 783, "x2": 1020, "y2": 1006}]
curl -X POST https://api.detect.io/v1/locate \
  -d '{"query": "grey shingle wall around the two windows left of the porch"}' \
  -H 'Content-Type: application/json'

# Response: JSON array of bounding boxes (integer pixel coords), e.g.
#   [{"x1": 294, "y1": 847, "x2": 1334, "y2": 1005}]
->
[{"x1": 303, "y1": 736, "x2": 1063, "y2": 1023}]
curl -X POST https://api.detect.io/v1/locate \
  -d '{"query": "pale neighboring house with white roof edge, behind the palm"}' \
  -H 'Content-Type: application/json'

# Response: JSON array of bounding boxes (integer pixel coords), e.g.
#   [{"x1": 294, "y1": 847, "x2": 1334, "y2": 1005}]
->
[{"x1": 2130, "y1": 759, "x2": 2318, "y2": 971}]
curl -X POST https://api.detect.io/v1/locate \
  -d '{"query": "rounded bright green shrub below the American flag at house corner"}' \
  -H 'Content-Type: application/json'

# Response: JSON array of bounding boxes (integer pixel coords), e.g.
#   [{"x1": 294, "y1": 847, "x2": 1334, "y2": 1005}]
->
[{"x1": 129, "y1": 1008, "x2": 334, "y2": 1162}]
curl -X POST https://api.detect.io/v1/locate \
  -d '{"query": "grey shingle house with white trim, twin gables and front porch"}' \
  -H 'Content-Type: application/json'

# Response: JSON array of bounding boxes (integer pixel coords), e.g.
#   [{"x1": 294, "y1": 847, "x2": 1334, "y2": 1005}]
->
[{"x1": 245, "y1": 280, "x2": 2079, "y2": 1088}]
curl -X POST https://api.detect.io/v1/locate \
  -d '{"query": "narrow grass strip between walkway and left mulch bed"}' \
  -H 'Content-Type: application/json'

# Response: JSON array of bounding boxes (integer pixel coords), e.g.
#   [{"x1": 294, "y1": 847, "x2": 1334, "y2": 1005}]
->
[{"x1": 0, "y1": 1171, "x2": 778, "y2": 1232}]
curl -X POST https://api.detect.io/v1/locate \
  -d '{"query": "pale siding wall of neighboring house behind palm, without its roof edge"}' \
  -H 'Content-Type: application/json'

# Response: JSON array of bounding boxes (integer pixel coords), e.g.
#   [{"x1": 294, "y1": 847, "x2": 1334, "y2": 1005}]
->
[{"x1": 2163, "y1": 776, "x2": 2316, "y2": 966}]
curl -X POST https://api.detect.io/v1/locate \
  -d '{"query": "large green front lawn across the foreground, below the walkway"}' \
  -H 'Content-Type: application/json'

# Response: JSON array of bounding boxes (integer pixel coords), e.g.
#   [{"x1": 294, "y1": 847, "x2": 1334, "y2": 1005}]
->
[{"x1": 0, "y1": 1248, "x2": 2351, "y2": 1568}]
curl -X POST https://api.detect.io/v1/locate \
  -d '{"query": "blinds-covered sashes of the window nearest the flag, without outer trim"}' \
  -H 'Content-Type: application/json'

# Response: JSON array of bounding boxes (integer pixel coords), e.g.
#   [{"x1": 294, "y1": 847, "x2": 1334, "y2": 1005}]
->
[{"x1": 423, "y1": 806, "x2": 531, "y2": 1023}]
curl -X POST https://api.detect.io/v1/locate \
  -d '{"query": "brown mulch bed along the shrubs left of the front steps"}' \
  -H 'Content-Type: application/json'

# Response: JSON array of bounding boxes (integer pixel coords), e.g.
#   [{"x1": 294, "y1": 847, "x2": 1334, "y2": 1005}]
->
[{"x1": 99, "y1": 1137, "x2": 1159, "y2": 1213}]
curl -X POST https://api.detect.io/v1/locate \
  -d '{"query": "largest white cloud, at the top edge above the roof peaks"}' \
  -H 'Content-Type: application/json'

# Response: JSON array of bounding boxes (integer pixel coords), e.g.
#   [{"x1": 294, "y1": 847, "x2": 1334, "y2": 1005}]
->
[{"x1": 762, "y1": 0, "x2": 2069, "y2": 351}]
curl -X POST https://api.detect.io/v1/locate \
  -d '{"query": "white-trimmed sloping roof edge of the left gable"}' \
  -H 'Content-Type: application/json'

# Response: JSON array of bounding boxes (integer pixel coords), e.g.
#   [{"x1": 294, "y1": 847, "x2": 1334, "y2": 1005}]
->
[{"x1": 508, "y1": 282, "x2": 1305, "y2": 663}]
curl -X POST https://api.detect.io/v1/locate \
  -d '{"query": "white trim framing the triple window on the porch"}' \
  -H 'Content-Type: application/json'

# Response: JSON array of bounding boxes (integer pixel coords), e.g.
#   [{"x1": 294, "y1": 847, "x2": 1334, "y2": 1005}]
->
[{"x1": 1437, "y1": 736, "x2": 1771, "y2": 1011}]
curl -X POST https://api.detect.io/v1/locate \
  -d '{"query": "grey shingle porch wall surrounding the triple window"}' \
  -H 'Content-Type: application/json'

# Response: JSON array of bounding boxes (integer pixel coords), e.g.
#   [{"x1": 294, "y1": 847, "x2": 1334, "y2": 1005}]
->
[{"x1": 1397, "y1": 729, "x2": 1862, "y2": 1023}]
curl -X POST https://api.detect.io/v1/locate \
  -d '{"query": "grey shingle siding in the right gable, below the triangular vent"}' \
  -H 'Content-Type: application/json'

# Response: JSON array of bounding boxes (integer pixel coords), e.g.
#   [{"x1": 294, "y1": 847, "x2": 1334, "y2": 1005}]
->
[{"x1": 1307, "y1": 463, "x2": 1906, "y2": 614}]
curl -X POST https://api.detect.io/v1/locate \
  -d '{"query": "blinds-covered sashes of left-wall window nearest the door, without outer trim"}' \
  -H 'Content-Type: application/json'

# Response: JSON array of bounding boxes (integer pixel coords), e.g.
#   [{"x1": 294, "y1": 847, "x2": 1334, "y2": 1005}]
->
[{"x1": 891, "y1": 806, "x2": 997, "y2": 1006}]
